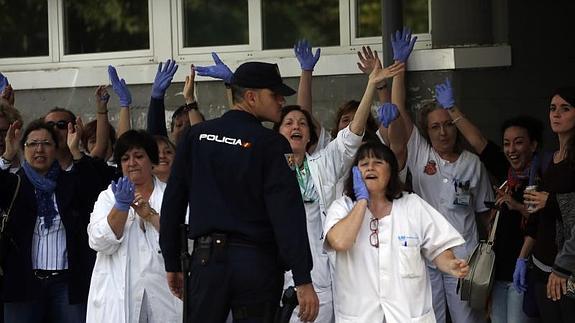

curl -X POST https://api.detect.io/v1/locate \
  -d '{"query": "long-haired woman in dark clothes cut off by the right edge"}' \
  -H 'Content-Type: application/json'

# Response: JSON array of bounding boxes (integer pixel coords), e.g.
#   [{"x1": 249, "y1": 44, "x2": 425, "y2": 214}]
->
[{"x1": 518, "y1": 87, "x2": 575, "y2": 323}]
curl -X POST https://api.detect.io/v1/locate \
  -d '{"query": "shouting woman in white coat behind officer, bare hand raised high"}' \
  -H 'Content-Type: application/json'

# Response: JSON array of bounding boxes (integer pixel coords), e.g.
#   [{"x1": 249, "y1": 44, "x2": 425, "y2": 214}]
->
[{"x1": 274, "y1": 57, "x2": 403, "y2": 323}]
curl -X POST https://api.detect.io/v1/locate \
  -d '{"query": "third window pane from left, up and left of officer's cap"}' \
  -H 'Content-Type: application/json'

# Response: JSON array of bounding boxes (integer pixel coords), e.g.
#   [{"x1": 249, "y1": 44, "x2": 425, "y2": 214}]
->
[{"x1": 183, "y1": 0, "x2": 249, "y2": 47}]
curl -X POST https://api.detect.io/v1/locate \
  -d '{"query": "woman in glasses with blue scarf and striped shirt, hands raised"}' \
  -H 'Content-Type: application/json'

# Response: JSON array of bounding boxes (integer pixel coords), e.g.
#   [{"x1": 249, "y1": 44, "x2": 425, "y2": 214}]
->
[{"x1": 0, "y1": 119, "x2": 99, "y2": 323}]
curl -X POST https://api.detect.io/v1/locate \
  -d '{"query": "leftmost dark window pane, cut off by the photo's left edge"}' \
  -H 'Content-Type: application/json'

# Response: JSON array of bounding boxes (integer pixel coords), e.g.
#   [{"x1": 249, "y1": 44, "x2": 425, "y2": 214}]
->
[{"x1": 0, "y1": 0, "x2": 49, "y2": 58}]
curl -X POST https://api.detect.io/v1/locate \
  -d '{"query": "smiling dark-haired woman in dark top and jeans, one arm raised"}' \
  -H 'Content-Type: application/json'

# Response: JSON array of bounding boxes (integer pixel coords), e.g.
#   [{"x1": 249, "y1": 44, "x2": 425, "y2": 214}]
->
[{"x1": 448, "y1": 101, "x2": 549, "y2": 323}]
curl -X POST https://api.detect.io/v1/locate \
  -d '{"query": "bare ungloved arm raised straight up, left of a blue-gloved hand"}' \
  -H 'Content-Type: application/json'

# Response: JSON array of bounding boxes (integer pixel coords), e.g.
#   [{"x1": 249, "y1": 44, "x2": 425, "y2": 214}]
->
[{"x1": 89, "y1": 85, "x2": 110, "y2": 159}]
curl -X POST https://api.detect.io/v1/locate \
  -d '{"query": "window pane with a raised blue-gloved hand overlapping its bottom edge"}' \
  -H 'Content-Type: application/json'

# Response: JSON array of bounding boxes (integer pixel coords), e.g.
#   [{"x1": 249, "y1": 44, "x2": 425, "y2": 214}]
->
[{"x1": 262, "y1": 0, "x2": 339, "y2": 49}]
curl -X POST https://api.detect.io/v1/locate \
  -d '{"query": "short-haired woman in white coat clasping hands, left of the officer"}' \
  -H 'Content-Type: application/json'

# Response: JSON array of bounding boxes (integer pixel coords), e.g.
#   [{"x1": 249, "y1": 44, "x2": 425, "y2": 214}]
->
[{"x1": 86, "y1": 130, "x2": 183, "y2": 323}]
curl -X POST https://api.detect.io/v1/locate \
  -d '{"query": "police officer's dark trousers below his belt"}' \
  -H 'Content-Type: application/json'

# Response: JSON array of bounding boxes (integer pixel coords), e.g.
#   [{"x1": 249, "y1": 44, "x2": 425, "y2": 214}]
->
[{"x1": 186, "y1": 243, "x2": 283, "y2": 323}]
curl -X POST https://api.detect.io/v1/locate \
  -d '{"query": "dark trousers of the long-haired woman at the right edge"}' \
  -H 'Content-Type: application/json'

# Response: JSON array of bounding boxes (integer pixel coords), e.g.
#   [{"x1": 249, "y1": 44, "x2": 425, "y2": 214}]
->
[{"x1": 532, "y1": 266, "x2": 575, "y2": 323}]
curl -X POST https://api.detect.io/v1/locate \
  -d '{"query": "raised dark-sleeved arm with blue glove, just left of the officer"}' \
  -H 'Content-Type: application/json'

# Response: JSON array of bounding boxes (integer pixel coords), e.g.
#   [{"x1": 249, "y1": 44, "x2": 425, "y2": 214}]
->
[{"x1": 146, "y1": 59, "x2": 178, "y2": 136}]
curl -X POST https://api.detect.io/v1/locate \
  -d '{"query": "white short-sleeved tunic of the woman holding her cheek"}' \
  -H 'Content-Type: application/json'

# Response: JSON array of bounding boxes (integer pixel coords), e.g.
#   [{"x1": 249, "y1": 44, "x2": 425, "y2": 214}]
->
[{"x1": 325, "y1": 193, "x2": 465, "y2": 323}]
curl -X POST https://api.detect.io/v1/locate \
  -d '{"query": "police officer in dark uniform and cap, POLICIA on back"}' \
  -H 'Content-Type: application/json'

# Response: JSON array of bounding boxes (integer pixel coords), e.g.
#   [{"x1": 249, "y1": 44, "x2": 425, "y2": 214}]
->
[{"x1": 160, "y1": 62, "x2": 319, "y2": 322}]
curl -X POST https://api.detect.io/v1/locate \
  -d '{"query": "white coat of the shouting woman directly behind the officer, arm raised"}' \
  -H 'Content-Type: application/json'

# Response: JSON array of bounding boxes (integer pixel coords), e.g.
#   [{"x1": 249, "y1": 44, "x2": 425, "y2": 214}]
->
[{"x1": 284, "y1": 126, "x2": 363, "y2": 323}]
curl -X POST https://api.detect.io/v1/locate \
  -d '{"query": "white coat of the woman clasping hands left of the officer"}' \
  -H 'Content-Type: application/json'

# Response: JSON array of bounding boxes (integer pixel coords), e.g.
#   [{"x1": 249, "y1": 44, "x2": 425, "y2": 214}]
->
[{"x1": 86, "y1": 177, "x2": 183, "y2": 323}]
